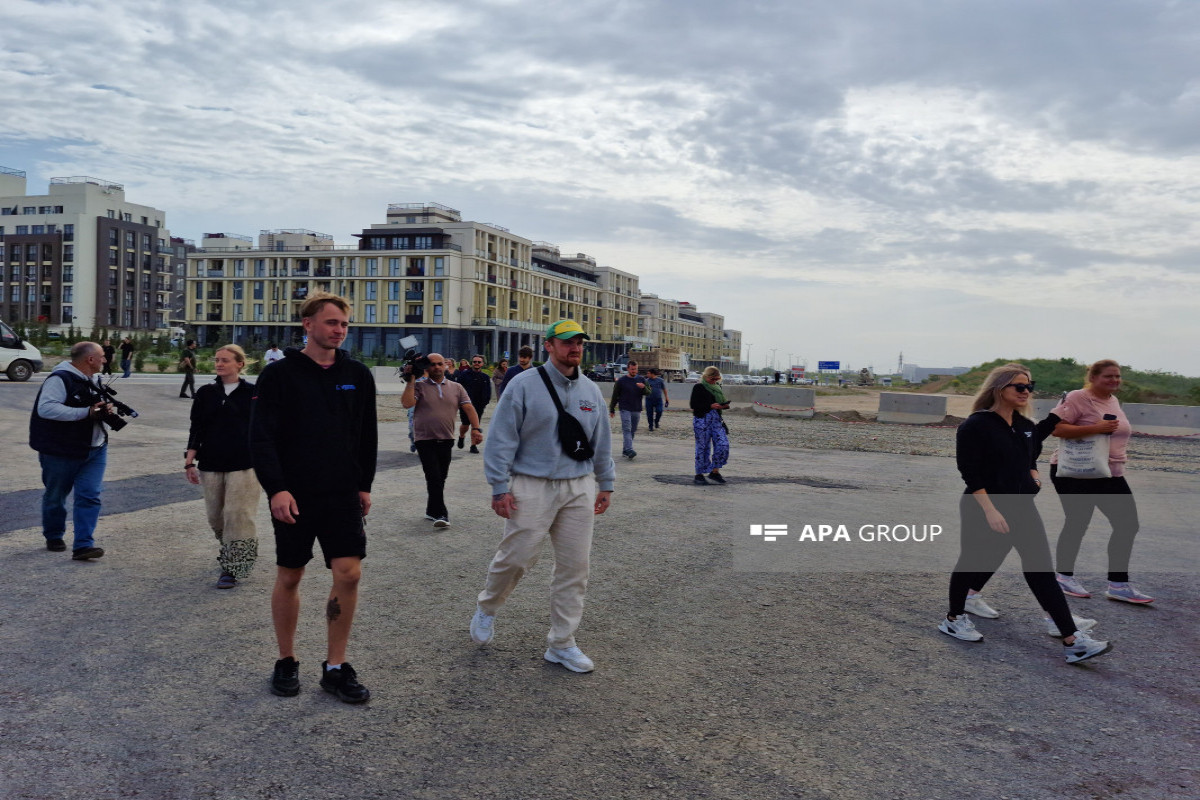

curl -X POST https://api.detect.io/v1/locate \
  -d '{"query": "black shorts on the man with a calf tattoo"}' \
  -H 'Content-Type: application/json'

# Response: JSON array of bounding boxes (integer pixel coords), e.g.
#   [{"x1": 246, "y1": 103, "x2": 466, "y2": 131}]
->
[{"x1": 271, "y1": 493, "x2": 367, "y2": 570}]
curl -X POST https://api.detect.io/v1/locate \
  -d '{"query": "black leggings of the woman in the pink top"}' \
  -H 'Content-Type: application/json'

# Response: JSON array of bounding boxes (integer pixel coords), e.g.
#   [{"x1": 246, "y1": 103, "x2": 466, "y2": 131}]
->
[{"x1": 1050, "y1": 464, "x2": 1140, "y2": 583}]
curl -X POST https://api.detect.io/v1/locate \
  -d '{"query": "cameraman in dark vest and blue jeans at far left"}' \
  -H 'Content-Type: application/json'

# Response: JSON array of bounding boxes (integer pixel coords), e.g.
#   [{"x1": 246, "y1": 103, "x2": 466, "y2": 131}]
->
[{"x1": 29, "y1": 342, "x2": 113, "y2": 561}]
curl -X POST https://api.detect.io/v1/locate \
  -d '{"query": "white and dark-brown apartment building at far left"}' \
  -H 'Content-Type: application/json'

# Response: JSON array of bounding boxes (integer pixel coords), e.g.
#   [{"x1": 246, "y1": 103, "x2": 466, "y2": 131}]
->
[{"x1": 0, "y1": 167, "x2": 188, "y2": 332}]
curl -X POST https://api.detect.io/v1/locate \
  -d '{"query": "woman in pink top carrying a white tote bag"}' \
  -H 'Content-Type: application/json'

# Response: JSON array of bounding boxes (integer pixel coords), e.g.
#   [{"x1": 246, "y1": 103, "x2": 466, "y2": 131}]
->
[{"x1": 1050, "y1": 359, "x2": 1154, "y2": 603}]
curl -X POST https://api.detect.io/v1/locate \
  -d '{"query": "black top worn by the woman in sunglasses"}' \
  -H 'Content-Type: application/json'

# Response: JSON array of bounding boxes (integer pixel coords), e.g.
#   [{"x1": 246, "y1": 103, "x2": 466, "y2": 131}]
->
[{"x1": 955, "y1": 411, "x2": 1060, "y2": 494}]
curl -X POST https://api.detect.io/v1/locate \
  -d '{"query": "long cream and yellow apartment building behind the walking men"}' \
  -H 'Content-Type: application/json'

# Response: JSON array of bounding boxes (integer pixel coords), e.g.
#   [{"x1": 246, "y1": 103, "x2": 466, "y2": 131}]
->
[{"x1": 186, "y1": 203, "x2": 641, "y2": 361}]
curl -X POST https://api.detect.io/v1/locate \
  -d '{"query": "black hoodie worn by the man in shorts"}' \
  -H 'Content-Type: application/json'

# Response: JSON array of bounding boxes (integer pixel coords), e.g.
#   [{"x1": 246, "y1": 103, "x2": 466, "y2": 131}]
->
[{"x1": 250, "y1": 348, "x2": 378, "y2": 497}]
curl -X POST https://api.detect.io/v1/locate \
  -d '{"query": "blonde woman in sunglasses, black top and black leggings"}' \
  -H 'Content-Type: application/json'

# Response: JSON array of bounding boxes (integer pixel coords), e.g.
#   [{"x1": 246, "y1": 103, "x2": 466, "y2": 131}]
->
[{"x1": 937, "y1": 363, "x2": 1111, "y2": 663}]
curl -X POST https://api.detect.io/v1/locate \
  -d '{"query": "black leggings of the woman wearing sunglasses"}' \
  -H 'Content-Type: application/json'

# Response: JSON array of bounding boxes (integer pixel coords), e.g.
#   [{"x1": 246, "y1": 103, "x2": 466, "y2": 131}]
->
[{"x1": 949, "y1": 494, "x2": 1075, "y2": 637}]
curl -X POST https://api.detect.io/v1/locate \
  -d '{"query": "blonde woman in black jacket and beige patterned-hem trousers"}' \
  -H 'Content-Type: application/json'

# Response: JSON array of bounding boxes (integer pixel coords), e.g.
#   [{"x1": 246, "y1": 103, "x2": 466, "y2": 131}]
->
[{"x1": 184, "y1": 344, "x2": 263, "y2": 589}]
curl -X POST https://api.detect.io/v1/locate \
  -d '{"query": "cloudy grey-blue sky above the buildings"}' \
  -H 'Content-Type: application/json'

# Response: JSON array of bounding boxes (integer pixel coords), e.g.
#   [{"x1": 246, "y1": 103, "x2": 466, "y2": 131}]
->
[{"x1": 0, "y1": 0, "x2": 1200, "y2": 375}]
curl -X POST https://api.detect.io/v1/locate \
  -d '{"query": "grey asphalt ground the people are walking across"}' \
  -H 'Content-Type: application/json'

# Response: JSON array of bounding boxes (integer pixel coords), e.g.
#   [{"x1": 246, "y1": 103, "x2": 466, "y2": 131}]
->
[{"x1": 0, "y1": 375, "x2": 1200, "y2": 800}]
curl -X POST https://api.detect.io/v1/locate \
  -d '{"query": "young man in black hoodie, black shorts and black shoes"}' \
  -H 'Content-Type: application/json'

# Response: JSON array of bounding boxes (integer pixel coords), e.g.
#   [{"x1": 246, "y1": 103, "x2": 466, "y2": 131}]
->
[{"x1": 250, "y1": 291, "x2": 378, "y2": 703}]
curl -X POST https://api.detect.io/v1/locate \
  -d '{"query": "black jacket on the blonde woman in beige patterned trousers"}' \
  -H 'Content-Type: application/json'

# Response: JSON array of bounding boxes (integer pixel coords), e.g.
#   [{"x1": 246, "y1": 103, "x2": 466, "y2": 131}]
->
[{"x1": 187, "y1": 378, "x2": 254, "y2": 473}]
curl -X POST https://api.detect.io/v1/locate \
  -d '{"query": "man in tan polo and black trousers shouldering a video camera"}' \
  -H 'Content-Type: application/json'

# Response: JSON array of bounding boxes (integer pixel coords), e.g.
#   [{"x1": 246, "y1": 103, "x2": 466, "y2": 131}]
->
[{"x1": 400, "y1": 353, "x2": 484, "y2": 528}]
